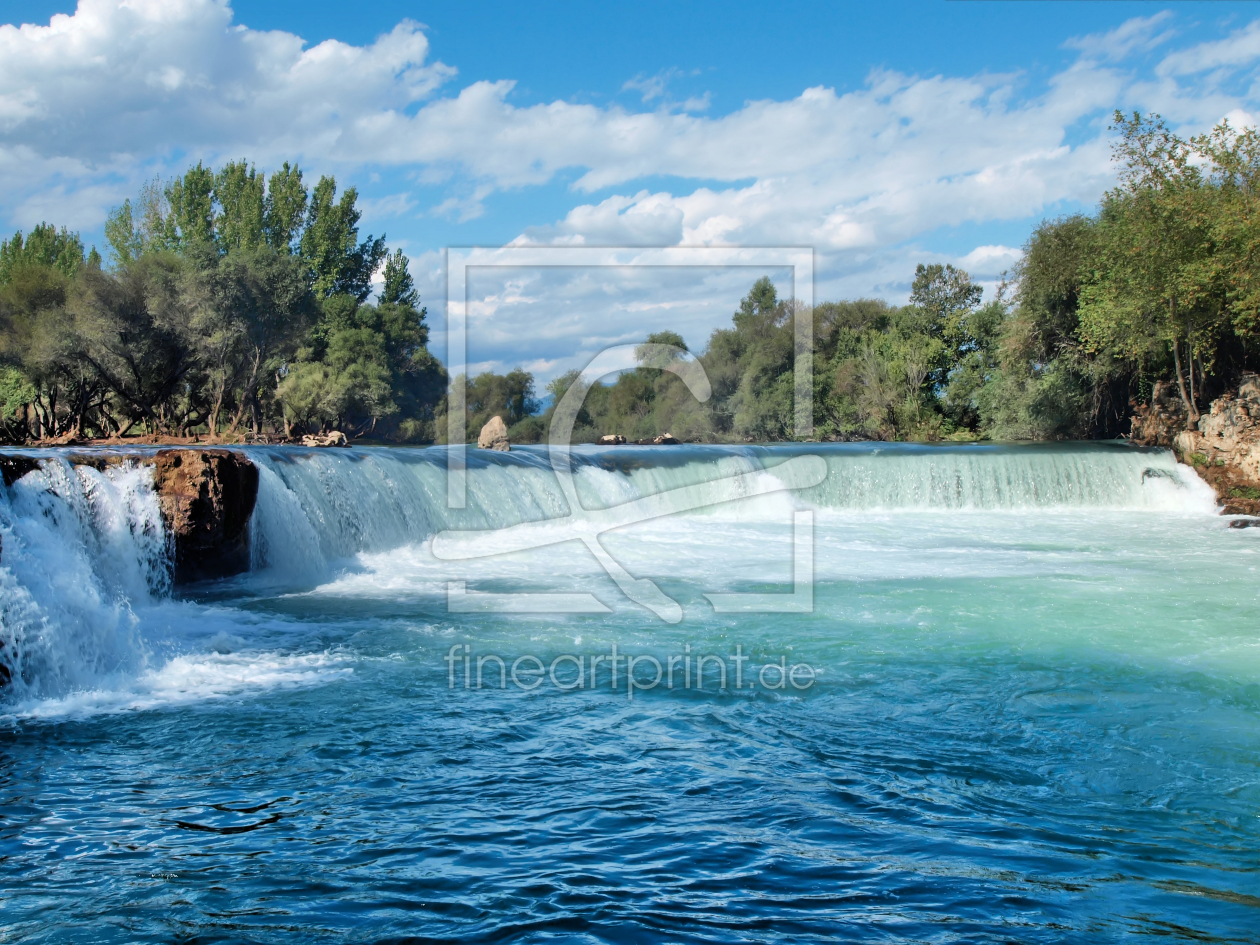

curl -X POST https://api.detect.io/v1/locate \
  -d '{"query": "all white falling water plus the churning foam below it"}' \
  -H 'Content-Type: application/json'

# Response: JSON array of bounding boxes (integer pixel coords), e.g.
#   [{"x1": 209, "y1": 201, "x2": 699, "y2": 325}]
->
[{"x1": 0, "y1": 445, "x2": 1225, "y2": 717}]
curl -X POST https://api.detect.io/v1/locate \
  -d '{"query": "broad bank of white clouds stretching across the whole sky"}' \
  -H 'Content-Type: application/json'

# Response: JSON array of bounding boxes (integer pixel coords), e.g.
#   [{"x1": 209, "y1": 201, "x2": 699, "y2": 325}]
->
[{"x1": 7, "y1": 0, "x2": 1260, "y2": 380}]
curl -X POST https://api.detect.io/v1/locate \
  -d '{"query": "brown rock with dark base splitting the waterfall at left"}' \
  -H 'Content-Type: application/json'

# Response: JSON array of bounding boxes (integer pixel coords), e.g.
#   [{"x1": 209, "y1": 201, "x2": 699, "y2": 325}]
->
[{"x1": 154, "y1": 450, "x2": 258, "y2": 583}]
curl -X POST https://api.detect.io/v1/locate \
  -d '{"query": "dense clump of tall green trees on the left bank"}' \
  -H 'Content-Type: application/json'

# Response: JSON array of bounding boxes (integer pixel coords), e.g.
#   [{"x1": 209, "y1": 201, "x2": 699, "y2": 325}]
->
[{"x1": 0, "y1": 161, "x2": 447, "y2": 442}]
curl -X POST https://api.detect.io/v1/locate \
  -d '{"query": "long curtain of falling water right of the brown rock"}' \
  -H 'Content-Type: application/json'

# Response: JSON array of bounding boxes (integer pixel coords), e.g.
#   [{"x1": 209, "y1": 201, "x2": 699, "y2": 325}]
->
[{"x1": 243, "y1": 445, "x2": 1215, "y2": 578}]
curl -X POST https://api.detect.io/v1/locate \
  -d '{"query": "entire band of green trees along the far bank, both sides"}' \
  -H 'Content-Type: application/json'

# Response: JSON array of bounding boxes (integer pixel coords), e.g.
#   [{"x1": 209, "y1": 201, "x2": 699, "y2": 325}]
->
[{"x1": 0, "y1": 112, "x2": 1260, "y2": 442}]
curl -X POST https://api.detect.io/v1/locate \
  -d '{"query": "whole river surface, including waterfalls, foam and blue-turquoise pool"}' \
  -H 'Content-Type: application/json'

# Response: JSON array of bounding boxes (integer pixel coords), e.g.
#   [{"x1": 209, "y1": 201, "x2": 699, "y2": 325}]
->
[{"x1": 0, "y1": 445, "x2": 1260, "y2": 942}]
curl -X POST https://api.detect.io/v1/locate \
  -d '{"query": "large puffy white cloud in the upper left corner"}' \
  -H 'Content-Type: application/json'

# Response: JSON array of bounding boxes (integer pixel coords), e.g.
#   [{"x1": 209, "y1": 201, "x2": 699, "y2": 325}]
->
[{"x1": 0, "y1": 0, "x2": 454, "y2": 168}]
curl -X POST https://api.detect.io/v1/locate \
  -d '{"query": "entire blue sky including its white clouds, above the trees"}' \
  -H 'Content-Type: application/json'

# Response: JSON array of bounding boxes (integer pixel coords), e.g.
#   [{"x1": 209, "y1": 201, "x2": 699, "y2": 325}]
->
[{"x1": 0, "y1": 0, "x2": 1260, "y2": 378}]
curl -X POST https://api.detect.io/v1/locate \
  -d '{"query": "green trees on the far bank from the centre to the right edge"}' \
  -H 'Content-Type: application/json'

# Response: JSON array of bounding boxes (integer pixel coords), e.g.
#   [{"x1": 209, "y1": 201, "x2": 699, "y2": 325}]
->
[{"x1": 456, "y1": 112, "x2": 1260, "y2": 441}]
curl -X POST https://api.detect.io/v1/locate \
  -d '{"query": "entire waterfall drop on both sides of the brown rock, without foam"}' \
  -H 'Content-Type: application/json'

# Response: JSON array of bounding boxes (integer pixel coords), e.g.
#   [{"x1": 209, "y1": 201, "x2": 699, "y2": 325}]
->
[{"x1": 0, "y1": 444, "x2": 1215, "y2": 701}]
